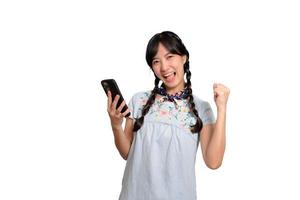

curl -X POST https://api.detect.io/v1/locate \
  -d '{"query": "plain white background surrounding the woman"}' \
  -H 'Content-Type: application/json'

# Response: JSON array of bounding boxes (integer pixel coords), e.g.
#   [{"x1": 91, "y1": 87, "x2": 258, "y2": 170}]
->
[{"x1": 0, "y1": 0, "x2": 300, "y2": 200}]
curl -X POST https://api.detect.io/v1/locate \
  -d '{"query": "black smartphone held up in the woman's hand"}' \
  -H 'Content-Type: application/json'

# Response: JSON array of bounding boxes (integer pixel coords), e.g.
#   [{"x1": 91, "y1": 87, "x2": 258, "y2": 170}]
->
[{"x1": 101, "y1": 79, "x2": 130, "y2": 117}]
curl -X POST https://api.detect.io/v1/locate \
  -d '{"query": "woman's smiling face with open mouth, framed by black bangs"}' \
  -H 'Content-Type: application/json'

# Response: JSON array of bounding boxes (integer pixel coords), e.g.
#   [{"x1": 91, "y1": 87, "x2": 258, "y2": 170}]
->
[{"x1": 152, "y1": 43, "x2": 187, "y2": 94}]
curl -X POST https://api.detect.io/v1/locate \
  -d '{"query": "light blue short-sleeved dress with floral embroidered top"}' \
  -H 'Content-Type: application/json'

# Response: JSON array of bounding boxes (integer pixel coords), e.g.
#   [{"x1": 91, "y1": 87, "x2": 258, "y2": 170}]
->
[{"x1": 119, "y1": 91, "x2": 215, "y2": 200}]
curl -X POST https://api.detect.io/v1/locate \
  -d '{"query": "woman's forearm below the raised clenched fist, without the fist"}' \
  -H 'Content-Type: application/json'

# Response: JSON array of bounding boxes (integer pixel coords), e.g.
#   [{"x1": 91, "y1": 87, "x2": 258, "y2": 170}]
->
[{"x1": 206, "y1": 108, "x2": 226, "y2": 168}]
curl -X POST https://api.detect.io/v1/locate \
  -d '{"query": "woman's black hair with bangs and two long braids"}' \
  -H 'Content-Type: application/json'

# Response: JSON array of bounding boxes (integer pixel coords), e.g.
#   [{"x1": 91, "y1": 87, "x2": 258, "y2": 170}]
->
[{"x1": 133, "y1": 31, "x2": 203, "y2": 133}]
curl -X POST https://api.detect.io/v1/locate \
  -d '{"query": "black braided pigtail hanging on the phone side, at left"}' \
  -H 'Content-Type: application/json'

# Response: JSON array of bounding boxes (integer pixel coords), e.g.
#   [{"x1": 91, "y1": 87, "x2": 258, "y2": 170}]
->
[{"x1": 133, "y1": 76, "x2": 159, "y2": 131}]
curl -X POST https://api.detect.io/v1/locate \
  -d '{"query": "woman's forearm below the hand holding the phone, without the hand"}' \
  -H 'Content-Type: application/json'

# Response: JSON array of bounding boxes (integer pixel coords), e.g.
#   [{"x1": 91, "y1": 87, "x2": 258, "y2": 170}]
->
[{"x1": 112, "y1": 125, "x2": 131, "y2": 160}]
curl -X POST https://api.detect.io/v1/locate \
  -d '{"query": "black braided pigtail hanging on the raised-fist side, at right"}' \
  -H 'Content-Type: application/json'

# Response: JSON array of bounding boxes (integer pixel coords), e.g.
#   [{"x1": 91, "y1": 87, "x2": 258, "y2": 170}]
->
[{"x1": 184, "y1": 61, "x2": 203, "y2": 133}]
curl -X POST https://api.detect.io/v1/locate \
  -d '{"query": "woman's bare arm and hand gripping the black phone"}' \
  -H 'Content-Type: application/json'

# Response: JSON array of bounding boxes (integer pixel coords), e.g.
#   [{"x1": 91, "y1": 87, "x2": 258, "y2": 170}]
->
[{"x1": 107, "y1": 92, "x2": 133, "y2": 160}]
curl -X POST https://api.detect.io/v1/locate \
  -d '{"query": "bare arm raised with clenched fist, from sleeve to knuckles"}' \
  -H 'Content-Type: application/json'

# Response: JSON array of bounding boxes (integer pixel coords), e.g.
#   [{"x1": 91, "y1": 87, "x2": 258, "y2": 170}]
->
[{"x1": 200, "y1": 84, "x2": 230, "y2": 169}]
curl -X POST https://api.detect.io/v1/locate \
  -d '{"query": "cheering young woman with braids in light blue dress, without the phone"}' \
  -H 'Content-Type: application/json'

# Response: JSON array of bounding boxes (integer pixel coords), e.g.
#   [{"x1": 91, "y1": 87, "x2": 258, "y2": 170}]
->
[{"x1": 107, "y1": 31, "x2": 229, "y2": 200}]
